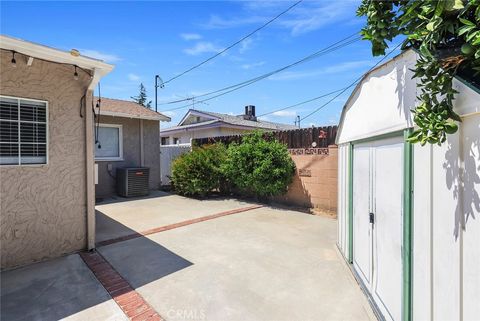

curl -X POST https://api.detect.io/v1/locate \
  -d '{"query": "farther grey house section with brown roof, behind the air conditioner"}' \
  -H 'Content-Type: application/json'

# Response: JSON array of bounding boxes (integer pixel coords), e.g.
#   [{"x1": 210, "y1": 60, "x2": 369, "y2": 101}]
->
[{"x1": 95, "y1": 97, "x2": 170, "y2": 198}]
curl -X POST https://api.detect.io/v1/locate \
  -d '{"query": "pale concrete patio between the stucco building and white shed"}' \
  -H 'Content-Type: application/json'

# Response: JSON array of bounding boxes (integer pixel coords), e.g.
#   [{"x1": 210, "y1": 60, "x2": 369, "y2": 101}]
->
[{"x1": 1, "y1": 193, "x2": 375, "y2": 321}]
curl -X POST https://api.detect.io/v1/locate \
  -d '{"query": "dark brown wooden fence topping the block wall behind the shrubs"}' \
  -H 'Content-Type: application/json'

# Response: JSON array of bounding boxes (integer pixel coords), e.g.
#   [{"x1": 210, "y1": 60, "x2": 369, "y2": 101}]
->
[{"x1": 192, "y1": 126, "x2": 337, "y2": 148}]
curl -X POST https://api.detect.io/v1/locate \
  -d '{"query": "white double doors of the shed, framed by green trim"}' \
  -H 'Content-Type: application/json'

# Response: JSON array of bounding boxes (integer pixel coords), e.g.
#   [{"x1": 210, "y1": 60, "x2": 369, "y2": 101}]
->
[{"x1": 353, "y1": 137, "x2": 403, "y2": 320}]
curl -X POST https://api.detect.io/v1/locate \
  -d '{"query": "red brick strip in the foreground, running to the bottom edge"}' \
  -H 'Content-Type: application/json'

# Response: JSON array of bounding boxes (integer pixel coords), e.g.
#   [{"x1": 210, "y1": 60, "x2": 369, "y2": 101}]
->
[{"x1": 80, "y1": 252, "x2": 164, "y2": 321}]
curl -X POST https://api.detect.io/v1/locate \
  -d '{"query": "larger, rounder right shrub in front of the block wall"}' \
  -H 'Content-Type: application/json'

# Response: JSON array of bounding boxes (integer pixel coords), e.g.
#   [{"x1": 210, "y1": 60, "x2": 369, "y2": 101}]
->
[{"x1": 222, "y1": 131, "x2": 295, "y2": 198}]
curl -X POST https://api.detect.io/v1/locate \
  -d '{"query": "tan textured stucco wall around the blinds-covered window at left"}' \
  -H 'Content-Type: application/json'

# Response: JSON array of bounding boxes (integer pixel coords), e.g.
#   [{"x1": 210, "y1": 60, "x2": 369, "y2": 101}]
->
[{"x1": 0, "y1": 52, "x2": 91, "y2": 269}]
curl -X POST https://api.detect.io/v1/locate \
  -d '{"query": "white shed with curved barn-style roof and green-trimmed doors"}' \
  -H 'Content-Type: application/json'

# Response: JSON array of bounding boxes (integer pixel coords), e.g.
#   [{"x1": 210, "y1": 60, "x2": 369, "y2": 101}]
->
[{"x1": 337, "y1": 50, "x2": 480, "y2": 320}]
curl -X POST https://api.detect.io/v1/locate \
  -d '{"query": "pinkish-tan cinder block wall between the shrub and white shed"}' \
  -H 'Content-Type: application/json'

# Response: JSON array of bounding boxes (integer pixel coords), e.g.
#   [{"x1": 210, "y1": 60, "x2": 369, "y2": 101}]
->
[{"x1": 275, "y1": 145, "x2": 338, "y2": 215}]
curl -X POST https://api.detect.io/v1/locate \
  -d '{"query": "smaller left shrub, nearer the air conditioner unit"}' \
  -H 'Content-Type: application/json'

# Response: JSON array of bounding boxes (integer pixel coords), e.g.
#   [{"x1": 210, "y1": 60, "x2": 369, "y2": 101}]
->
[{"x1": 172, "y1": 144, "x2": 226, "y2": 197}]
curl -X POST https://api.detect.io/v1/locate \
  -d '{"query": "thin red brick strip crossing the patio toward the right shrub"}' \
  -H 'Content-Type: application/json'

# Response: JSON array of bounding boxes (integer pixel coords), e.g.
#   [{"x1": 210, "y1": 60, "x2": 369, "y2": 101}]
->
[{"x1": 96, "y1": 205, "x2": 263, "y2": 247}]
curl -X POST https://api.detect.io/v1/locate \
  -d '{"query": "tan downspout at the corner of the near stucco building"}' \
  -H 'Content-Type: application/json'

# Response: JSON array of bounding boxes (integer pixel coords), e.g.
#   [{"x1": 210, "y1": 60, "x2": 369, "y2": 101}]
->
[{"x1": 85, "y1": 68, "x2": 100, "y2": 250}]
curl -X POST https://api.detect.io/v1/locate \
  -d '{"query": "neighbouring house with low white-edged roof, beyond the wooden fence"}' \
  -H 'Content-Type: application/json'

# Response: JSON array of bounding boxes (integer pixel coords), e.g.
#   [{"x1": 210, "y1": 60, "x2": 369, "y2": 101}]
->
[{"x1": 160, "y1": 106, "x2": 297, "y2": 145}]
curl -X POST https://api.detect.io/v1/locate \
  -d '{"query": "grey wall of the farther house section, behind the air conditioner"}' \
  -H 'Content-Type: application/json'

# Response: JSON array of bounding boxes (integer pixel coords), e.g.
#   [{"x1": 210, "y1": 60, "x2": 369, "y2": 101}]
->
[{"x1": 95, "y1": 116, "x2": 160, "y2": 197}]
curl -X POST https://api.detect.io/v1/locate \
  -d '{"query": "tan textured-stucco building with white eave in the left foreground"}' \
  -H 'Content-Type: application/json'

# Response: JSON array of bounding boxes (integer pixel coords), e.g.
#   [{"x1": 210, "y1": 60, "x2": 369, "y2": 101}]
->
[{"x1": 0, "y1": 35, "x2": 113, "y2": 269}]
